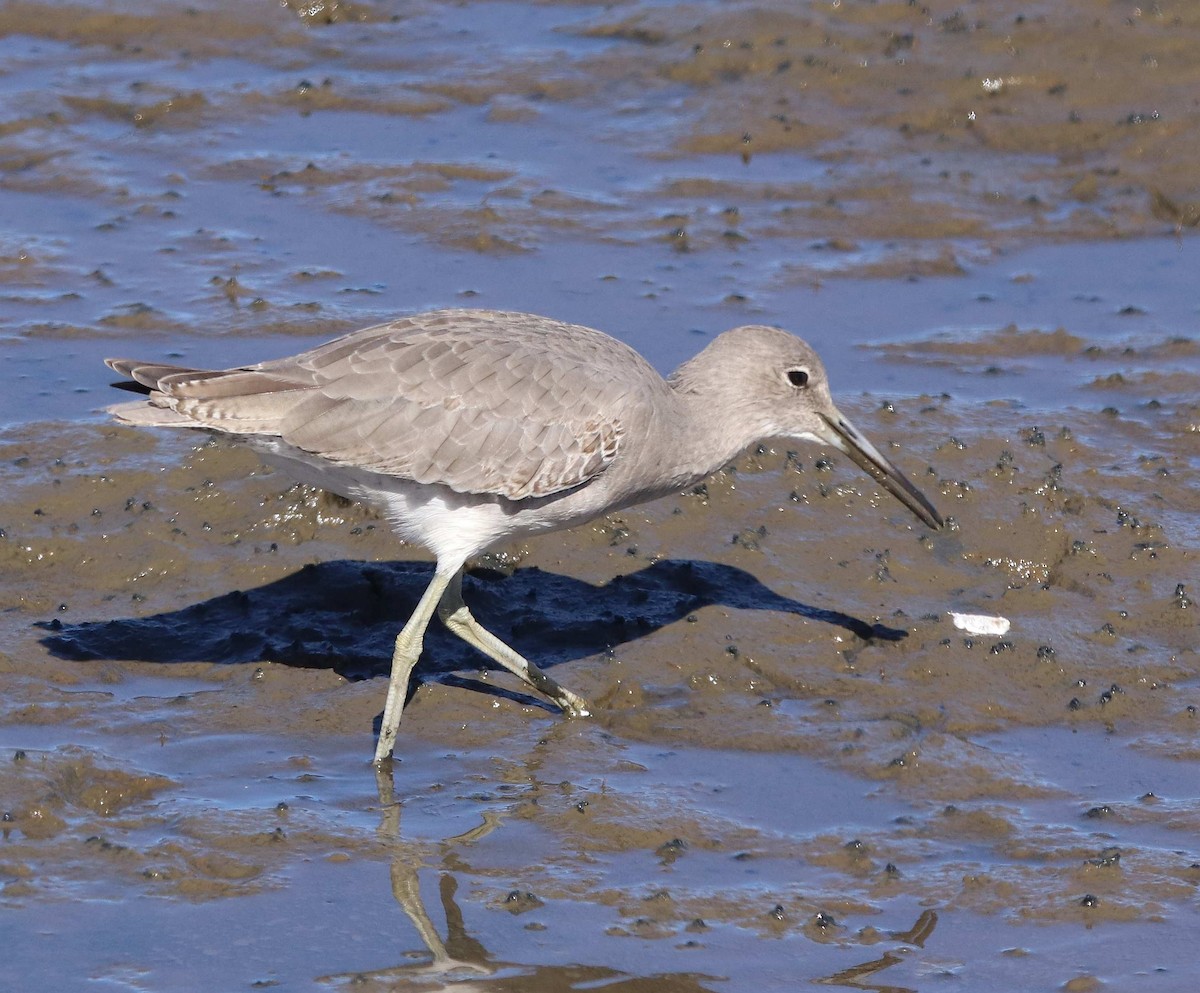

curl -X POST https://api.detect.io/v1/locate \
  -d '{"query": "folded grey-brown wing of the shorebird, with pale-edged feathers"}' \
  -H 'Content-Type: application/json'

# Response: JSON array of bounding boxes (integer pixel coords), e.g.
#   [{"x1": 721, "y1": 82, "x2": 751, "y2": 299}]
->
[{"x1": 109, "y1": 311, "x2": 668, "y2": 500}]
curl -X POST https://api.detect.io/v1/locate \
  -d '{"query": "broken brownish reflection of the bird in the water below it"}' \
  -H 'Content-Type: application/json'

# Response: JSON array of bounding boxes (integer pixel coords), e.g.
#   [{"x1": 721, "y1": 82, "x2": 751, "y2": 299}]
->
[{"x1": 317, "y1": 759, "x2": 937, "y2": 993}]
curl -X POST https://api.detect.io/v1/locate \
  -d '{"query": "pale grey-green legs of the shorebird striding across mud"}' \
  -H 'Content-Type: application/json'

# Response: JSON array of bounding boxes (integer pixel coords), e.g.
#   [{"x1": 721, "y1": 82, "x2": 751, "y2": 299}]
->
[{"x1": 376, "y1": 565, "x2": 592, "y2": 762}]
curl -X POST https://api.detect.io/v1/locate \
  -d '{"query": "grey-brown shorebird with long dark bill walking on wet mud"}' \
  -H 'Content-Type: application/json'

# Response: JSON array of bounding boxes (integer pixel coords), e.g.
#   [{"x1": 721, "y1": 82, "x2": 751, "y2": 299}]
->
[{"x1": 107, "y1": 311, "x2": 943, "y2": 763}]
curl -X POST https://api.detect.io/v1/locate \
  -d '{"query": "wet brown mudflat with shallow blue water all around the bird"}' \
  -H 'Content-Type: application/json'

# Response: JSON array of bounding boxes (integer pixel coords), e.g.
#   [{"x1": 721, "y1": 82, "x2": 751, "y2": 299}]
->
[{"x1": 0, "y1": 2, "x2": 1200, "y2": 993}]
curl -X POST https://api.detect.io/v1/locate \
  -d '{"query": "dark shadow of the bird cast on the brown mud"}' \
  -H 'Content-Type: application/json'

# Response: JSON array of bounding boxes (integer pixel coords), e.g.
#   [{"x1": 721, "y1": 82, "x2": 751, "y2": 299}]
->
[{"x1": 37, "y1": 560, "x2": 906, "y2": 680}]
